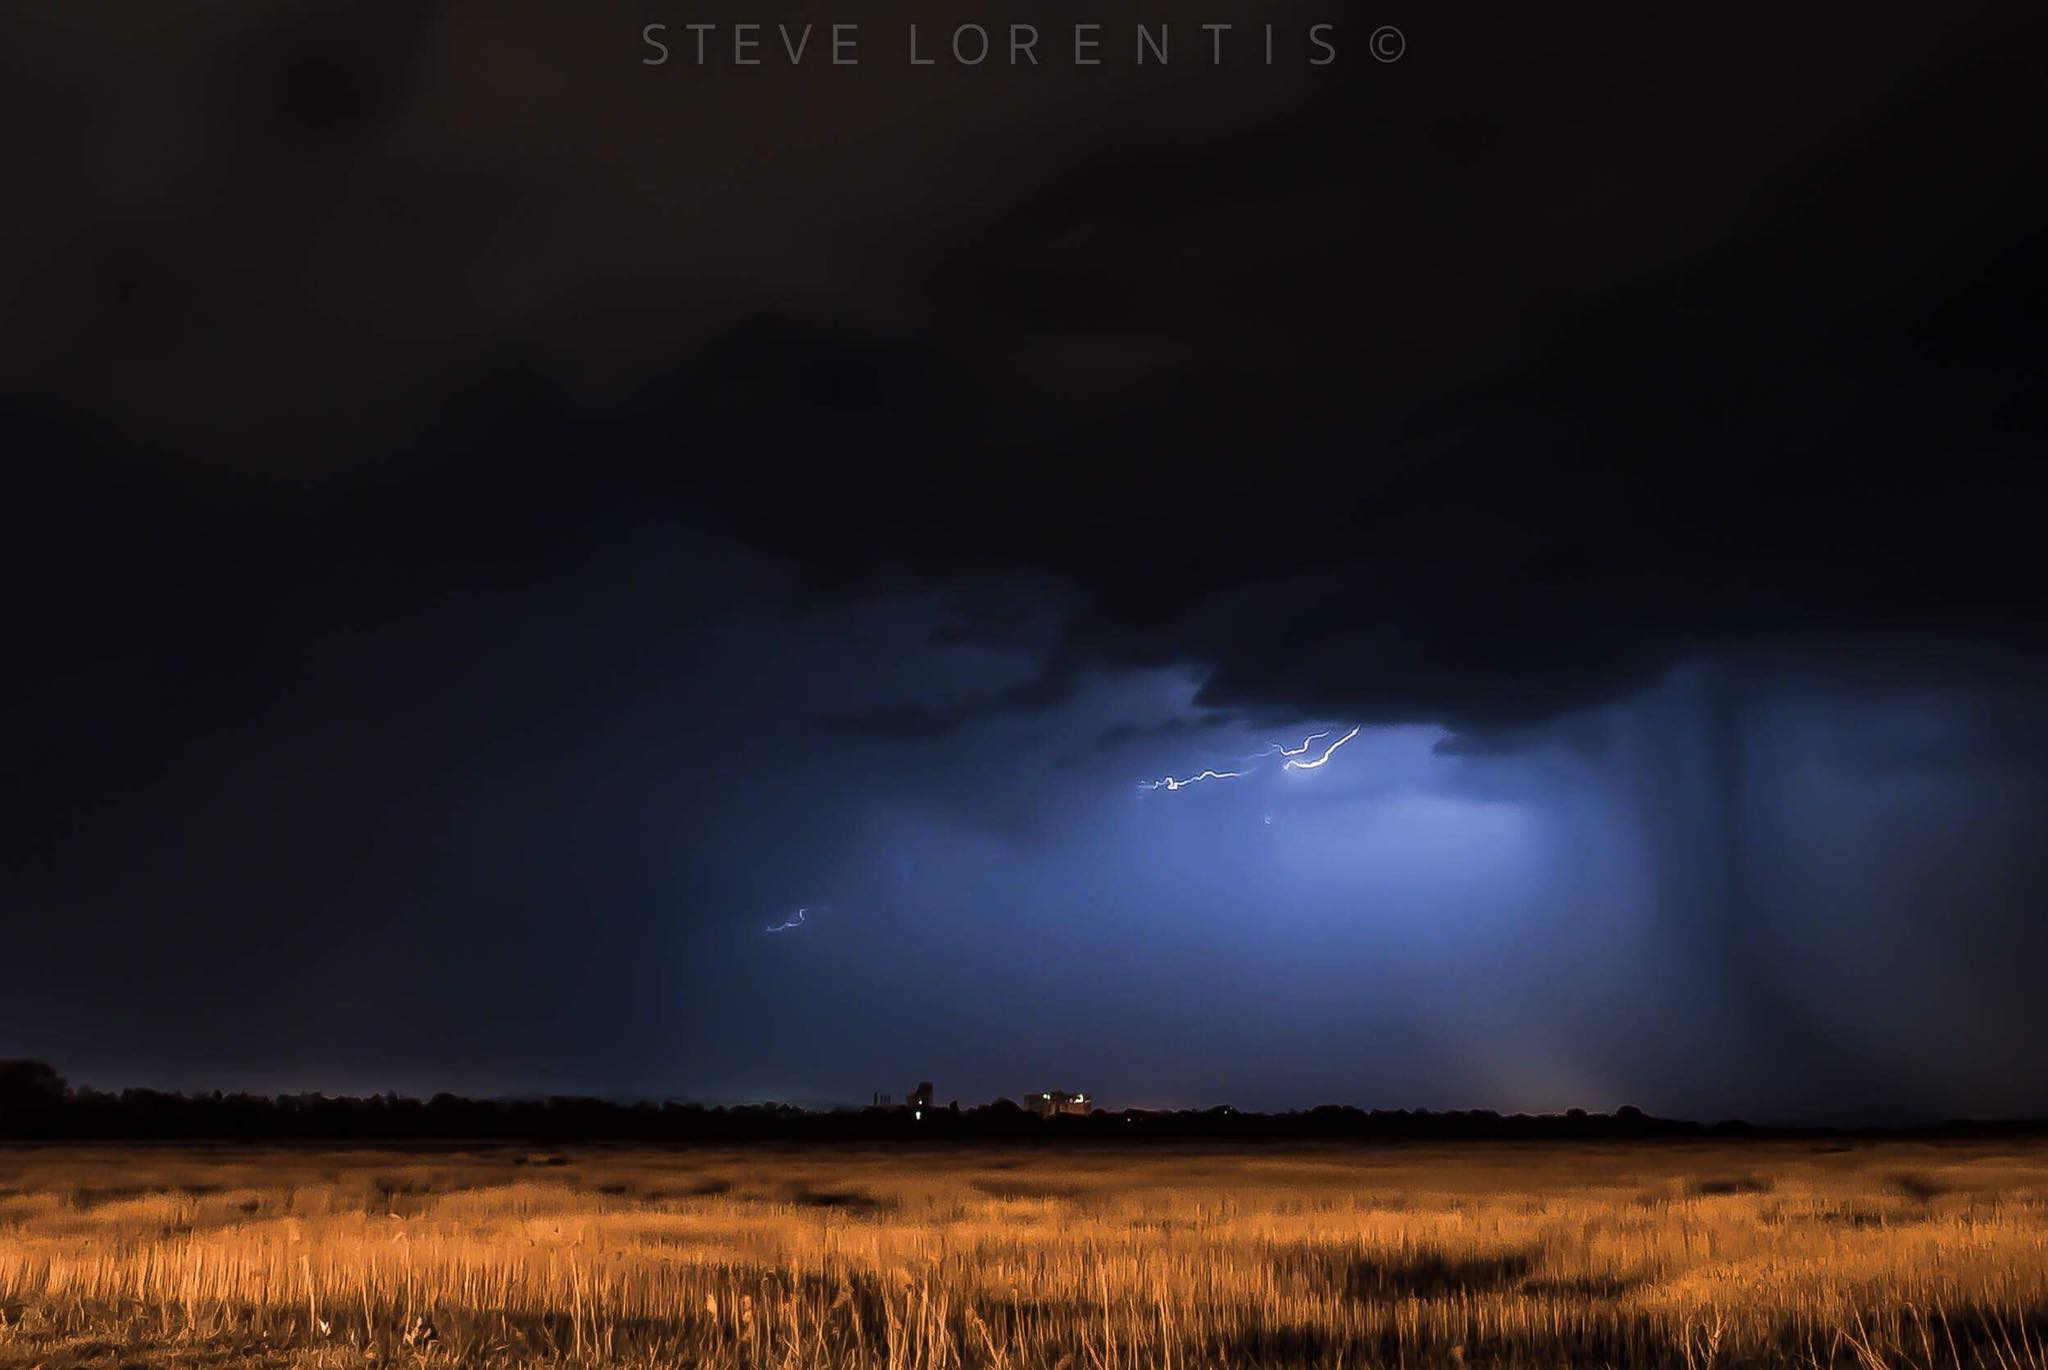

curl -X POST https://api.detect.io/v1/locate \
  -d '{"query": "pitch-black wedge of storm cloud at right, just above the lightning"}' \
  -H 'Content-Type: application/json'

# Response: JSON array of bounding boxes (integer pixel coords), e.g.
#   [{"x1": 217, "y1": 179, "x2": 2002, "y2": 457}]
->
[{"x1": 978, "y1": 34, "x2": 2048, "y2": 727}]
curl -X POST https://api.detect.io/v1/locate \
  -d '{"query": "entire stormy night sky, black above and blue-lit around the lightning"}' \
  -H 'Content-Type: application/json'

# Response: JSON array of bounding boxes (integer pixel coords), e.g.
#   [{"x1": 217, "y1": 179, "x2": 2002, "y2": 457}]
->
[{"x1": 0, "y1": 0, "x2": 2048, "y2": 1122}]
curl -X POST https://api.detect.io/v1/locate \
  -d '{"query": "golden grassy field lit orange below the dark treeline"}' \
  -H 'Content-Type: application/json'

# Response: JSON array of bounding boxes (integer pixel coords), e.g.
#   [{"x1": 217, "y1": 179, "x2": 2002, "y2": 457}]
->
[{"x1": 0, "y1": 1143, "x2": 2048, "y2": 1370}]
